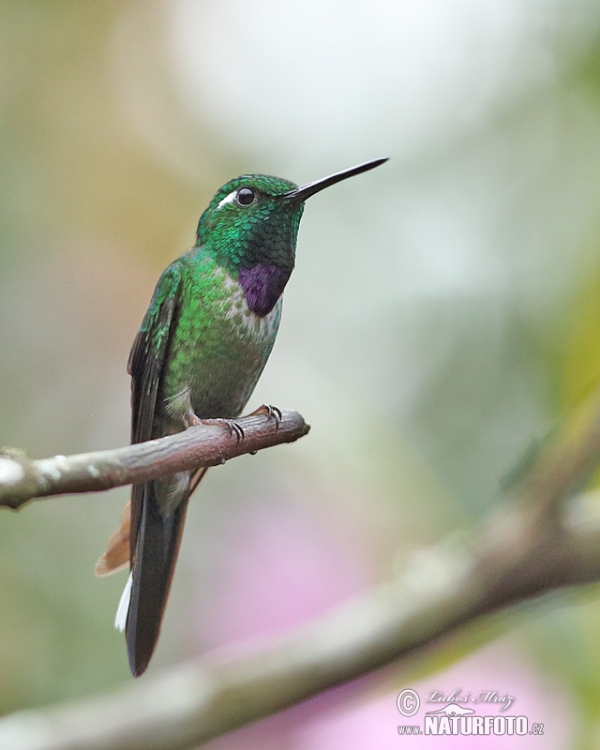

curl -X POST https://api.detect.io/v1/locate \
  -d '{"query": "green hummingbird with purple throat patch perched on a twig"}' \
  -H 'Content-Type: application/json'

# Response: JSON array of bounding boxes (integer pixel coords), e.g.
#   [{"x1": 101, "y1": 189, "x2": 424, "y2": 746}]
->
[{"x1": 96, "y1": 158, "x2": 387, "y2": 677}]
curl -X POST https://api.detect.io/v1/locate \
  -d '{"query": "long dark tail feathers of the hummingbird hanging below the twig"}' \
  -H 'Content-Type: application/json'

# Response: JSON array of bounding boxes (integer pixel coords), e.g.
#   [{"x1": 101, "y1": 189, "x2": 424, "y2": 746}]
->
[{"x1": 125, "y1": 482, "x2": 189, "y2": 677}]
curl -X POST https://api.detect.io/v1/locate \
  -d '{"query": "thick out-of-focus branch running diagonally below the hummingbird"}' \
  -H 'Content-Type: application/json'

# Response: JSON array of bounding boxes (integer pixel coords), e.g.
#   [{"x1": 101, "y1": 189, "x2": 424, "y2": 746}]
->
[{"x1": 0, "y1": 396, "x2": 600, "y2": 750}]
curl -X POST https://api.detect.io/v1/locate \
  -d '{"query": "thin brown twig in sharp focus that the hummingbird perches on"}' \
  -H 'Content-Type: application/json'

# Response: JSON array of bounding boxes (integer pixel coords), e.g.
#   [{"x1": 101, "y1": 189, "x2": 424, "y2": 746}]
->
[{"x1": 0, "y1": 411, "x2": 310, "y2": 509}]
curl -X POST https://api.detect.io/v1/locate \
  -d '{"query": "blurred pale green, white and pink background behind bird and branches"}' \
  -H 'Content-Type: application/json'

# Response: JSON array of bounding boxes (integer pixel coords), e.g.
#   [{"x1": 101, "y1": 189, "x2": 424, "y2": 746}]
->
[{"x1": 0, "y1": 0, "x2": 600, "y2": 750}]
